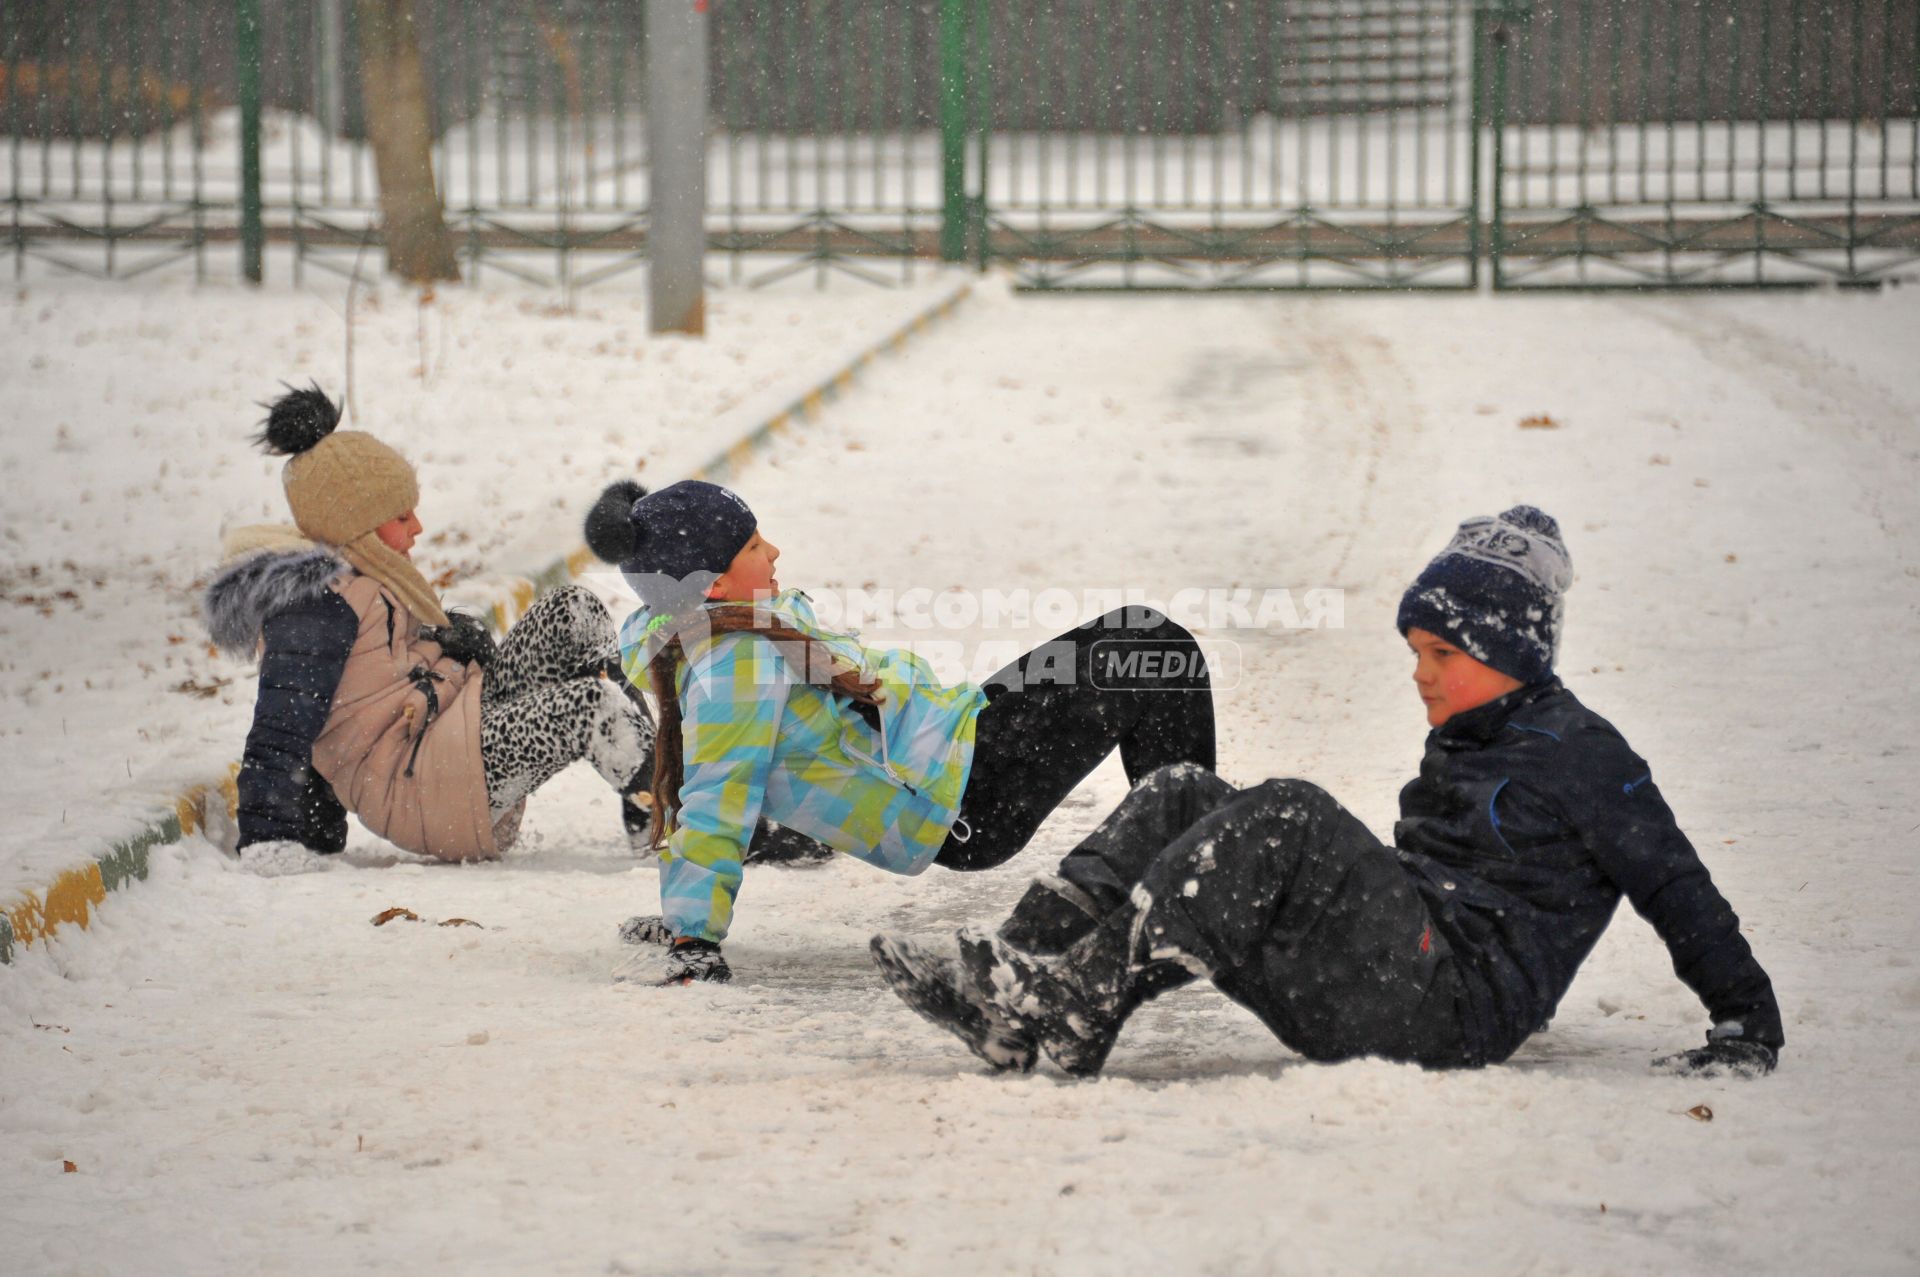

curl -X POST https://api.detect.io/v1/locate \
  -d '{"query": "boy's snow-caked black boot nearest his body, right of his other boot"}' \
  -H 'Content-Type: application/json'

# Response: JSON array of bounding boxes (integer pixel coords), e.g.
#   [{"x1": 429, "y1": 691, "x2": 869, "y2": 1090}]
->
[{"x1": 960, "y1": 910, "x2": 1146, "y2": 1077}]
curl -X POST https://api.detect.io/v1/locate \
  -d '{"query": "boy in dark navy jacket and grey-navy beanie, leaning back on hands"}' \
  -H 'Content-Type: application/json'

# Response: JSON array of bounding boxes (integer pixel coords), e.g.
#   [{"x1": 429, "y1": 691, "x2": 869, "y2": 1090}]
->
[{"x1": 874, "y1": 505, "x2": 1784, "y2": 1075}]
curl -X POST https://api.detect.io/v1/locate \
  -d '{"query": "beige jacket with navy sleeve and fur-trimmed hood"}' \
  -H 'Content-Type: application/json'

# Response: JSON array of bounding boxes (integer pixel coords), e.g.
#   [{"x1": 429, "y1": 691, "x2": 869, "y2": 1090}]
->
[{"x1": 204, "y1": 530, "x2": 499, "y2": 860}]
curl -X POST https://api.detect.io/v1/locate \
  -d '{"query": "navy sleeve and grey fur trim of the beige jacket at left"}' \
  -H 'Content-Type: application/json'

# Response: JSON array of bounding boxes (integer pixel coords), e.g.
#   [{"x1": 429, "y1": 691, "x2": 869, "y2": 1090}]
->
[{"x1": 204, "y1": 549, "x2": 359, "y2": 853}]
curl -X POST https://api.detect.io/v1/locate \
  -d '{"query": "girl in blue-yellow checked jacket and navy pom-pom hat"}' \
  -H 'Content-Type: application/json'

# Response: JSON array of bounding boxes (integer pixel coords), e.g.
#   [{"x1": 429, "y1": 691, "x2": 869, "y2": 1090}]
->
[{"x1": 588, "y1": 480, "x2": 1213, "y2": 983}]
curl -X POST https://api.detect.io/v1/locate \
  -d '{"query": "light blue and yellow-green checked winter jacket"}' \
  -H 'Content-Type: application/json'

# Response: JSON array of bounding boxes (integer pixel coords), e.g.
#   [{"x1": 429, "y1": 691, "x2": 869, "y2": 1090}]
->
[{"x1": 620, "y1": 590, "x2": 987, "y2": 941}]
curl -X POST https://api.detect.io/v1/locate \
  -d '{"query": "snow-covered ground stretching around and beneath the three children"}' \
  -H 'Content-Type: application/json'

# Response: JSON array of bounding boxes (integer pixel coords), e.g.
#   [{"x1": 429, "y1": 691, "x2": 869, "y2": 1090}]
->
[{"x1": 0, "y1": 274, "x2": 1920, "y2": 1275}]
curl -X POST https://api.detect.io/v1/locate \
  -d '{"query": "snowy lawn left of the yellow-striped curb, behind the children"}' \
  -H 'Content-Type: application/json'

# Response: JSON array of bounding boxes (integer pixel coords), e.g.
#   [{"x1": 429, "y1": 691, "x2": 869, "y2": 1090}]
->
[{"x1": 0, "y1": 259, "x2": 960, "y2": 895}]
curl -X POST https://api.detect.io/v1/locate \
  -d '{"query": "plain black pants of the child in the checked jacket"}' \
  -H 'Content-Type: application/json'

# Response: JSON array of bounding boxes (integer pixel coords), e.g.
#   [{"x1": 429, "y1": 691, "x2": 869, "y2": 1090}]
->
[{"x1": 935, "y1": 607, "x2": 1213, "y2": 870}]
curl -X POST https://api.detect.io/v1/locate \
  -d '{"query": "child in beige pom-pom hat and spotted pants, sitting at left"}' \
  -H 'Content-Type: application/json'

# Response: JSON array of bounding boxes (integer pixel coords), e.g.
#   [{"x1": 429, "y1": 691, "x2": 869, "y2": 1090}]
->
[{"x1": 204, "y1": 388, "x2": 653, "y2": 872}]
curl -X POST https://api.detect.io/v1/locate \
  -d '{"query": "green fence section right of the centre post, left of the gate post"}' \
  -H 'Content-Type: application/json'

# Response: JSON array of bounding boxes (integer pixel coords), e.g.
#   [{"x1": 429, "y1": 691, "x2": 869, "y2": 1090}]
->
[{"x1": 952, "y1": 0, "x2": 1476, "y2": 288}]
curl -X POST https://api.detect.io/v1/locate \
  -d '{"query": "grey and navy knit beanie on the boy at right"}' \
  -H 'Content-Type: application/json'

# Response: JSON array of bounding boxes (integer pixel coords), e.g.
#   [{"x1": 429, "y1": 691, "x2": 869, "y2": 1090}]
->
[{"x1": 1396, "y1": 505, "x2": 1572, "y2": 684}]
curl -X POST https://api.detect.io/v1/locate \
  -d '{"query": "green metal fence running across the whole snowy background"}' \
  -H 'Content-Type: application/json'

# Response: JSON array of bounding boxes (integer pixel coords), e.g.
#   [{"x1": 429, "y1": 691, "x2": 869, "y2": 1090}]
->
[{"x1": 0, "y1": 0, "x2": 1920, "y2": 288}]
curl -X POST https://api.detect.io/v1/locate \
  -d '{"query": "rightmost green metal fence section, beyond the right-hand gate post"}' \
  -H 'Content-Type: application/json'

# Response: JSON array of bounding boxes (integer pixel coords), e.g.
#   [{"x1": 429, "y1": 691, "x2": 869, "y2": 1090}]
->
[{"x1": 1486, "y1": 0, "x2": 1920, "y2": 288}]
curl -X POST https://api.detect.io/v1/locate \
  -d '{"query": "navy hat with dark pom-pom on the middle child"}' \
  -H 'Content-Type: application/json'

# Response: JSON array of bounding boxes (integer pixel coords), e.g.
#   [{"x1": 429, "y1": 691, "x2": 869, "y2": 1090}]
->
[{"x1": 588, "y1": 478, "x2": 760, "y2": 611}]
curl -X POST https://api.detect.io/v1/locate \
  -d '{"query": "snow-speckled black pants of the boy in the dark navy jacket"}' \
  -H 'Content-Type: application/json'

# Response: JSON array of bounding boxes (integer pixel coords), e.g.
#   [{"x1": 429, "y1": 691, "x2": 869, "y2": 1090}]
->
[{"x1": 1060, "y1": 766, "x2": 1476, "y2": 1068}]
